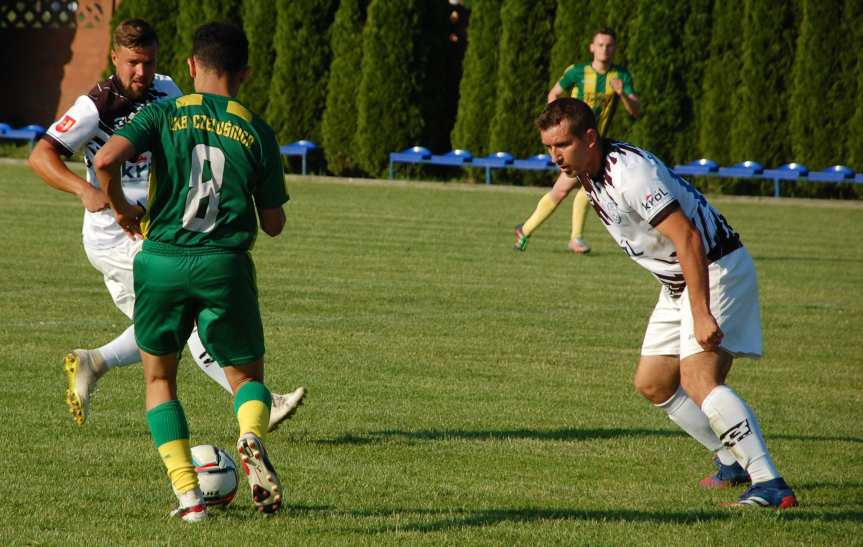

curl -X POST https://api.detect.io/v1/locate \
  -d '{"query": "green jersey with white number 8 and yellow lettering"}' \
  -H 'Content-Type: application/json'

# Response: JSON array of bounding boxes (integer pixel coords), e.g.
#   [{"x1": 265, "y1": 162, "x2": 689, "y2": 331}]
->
[{"x1": 117, "y1": 93, "x2": 288, "y2": 251}]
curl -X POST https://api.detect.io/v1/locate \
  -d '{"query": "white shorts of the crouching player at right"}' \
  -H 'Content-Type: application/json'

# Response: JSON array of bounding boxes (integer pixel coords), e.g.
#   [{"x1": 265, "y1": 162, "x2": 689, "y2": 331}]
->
[{"x1": 641, "y1": 247, "x2": 763, "y2": 359}]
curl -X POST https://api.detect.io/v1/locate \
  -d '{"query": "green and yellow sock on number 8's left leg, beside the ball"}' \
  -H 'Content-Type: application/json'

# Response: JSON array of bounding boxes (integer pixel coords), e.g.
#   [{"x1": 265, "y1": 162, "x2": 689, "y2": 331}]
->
[{"x1": 147, "y1": 400, "x2": 198, "y2": 494}]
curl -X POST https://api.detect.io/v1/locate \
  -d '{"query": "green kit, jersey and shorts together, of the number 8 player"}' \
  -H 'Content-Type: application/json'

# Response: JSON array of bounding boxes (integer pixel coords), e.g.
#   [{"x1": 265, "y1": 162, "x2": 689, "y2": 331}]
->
[{"x1": 117, "y1": 93, "x2": 288, "y2": 366}]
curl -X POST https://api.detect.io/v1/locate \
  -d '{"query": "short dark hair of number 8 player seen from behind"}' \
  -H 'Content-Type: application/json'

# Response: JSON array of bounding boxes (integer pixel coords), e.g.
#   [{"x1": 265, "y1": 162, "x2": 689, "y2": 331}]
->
[{"x1": 192, "y1": 22, "x2": 249, "y2": 74}]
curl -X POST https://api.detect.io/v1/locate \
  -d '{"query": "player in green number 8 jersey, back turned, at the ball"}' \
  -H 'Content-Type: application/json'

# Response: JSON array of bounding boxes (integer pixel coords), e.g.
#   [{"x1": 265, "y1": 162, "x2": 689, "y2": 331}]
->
[{"x1": 95, "y1": 23, "x2": 288, "y2": 522}]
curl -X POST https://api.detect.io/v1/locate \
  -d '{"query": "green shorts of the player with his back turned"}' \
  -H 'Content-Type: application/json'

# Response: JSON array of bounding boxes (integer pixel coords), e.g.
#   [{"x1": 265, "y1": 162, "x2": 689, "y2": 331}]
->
[{"x1": 134, "y1": 241, "x2": 264, "y2": 367}]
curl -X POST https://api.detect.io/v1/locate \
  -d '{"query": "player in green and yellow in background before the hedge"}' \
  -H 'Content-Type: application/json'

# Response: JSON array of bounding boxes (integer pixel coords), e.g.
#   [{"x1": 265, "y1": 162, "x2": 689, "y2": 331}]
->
[{"x1": 515, "y1": 28, "x2": 641, "y2": 253}]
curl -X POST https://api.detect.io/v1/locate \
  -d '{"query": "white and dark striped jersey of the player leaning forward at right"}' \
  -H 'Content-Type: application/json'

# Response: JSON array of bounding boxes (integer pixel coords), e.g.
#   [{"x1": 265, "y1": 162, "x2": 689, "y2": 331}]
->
[{"x1": 582, "y1": 140, "x2": 742, "y2": 298}]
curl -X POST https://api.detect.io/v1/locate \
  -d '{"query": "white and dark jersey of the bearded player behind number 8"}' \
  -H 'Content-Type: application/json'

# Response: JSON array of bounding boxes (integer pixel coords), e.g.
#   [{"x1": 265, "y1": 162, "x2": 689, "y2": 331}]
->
[{"x1": 44, "y1": 74, "x2": 182, "y2": 249}]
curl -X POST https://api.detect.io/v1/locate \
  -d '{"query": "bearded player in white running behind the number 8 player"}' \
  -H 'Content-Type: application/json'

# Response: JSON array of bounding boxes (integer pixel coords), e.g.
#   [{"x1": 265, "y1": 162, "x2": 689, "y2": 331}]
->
[{"x1": 30, "y1": 19, "x2": 305, "y2": 430}]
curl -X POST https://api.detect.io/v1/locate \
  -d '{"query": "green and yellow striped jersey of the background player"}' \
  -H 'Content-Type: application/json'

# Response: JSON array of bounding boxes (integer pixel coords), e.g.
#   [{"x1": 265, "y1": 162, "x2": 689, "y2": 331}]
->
[{"x1": 560, "y1": 63, "x2": 635, "y2": 137}]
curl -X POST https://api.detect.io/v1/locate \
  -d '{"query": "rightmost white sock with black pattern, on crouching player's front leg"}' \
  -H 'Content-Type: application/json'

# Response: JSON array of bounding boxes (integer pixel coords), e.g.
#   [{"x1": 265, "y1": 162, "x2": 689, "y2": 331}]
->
[{"x1": 701, "y1": 386, "x2": 779, "y2": 483}]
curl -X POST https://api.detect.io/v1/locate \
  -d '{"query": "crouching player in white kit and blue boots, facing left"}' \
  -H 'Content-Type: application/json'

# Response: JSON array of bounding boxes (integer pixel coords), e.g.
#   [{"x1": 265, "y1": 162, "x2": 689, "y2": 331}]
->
[{"x1": 536, "y1": 98, "x2": 797, "y2": 509}]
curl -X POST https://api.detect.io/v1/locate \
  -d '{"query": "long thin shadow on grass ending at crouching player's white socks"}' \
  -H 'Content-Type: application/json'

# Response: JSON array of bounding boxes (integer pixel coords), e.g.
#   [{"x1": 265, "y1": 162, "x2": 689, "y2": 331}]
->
[{"x1": 316, "y1": 428, "x2": 686, "y2": 445}]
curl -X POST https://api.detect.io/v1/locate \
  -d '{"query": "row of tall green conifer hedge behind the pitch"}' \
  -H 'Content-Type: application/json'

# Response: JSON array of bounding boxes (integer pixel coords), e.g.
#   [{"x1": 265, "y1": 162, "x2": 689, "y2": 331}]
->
[{"x1": 114, "y1": 0, "x2": 863, "y2": 195}]
